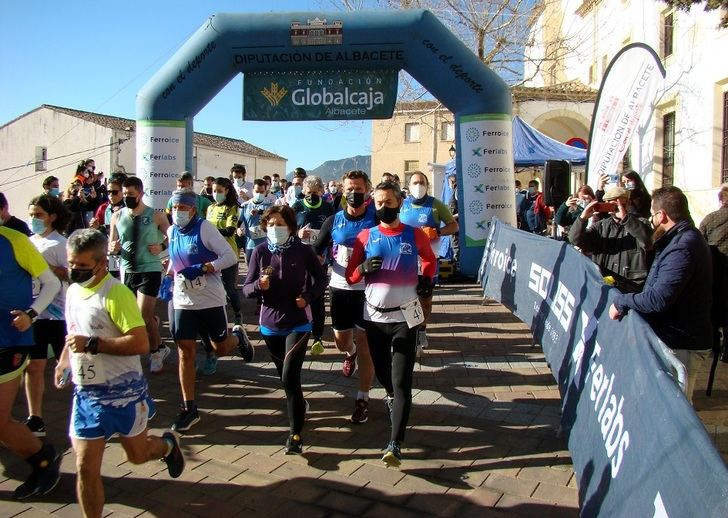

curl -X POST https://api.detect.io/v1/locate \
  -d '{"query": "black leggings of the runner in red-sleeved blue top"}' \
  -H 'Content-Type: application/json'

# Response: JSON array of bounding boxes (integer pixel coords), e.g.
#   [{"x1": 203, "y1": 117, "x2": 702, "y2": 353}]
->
[{"x1": 366, "y1": 321, "x2": 417, "y2": 442}]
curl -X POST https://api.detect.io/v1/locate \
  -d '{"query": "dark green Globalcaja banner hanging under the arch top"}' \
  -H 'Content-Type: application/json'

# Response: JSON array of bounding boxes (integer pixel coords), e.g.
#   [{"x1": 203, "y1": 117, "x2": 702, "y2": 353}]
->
[{"x1": 243, "y1": 70, "x2": 398, "y2": 121}]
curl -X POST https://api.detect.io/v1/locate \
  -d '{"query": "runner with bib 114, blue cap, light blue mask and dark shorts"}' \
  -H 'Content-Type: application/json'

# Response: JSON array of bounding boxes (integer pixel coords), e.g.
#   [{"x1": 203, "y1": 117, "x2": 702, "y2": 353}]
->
[{"x1": 167, "y1": 190, "x2": 254, "y2": 432}]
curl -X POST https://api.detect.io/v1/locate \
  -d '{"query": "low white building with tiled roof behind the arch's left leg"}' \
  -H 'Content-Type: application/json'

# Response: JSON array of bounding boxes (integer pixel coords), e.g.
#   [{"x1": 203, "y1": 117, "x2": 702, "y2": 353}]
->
[{"x1": 0, "y1": 104, "x2": 286, "y2": 218}]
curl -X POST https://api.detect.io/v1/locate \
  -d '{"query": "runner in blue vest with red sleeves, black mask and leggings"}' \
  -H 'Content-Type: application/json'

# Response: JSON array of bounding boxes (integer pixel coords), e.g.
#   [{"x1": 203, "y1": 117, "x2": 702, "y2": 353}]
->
[{"x1": 346, "y1": 182, "x2": 436, "y2": 467}]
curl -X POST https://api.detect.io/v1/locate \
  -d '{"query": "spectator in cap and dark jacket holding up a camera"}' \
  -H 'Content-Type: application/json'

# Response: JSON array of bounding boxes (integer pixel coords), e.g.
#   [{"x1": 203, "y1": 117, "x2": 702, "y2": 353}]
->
[{"x1": 569, "y1": 186, "x2": 652, "y2": 292}]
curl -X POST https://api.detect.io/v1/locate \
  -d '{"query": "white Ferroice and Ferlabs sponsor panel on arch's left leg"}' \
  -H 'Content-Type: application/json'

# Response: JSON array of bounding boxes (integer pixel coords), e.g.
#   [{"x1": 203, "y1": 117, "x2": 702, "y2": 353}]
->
[{"x1": 136, "y1": 120, "x2": 185, "y2": 209}]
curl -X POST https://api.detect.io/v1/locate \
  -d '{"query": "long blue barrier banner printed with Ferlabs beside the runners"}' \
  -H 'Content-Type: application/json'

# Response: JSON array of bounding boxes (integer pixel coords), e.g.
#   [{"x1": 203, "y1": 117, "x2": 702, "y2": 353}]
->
[{"x1": 479, "y1": 219, "x2": 728, "y2": 517}]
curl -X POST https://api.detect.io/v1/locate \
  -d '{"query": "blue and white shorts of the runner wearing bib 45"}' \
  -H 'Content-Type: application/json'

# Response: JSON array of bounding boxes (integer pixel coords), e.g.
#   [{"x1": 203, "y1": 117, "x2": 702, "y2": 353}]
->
[{"x1": 68, "y1": 392, "x2": 157, "y2": 440}]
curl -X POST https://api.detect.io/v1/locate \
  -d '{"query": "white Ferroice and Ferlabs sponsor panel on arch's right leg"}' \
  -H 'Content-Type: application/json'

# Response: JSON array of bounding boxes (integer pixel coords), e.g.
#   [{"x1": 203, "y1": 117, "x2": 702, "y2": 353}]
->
[{"x1": 458, "y1": 113, "x2": 516, "y2": 246}]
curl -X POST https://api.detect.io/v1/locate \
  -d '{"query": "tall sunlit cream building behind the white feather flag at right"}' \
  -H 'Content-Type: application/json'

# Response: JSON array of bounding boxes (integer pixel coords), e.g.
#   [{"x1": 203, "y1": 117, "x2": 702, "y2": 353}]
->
[{"x1": 525, "y1": 0, "x2": 728, "y2": 221}]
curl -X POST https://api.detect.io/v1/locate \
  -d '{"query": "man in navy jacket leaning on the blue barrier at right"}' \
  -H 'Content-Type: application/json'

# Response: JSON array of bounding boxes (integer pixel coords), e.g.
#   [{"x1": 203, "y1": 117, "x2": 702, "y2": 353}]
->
[{"x1": 609, "y1": 187, "x2": 713, "y2": 401}]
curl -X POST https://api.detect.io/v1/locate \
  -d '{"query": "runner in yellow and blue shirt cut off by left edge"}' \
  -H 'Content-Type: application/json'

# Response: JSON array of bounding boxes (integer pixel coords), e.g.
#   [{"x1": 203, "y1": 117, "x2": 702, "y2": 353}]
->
[{"x1": 0, "y1": 217, "x2": 62, "y2": 500}]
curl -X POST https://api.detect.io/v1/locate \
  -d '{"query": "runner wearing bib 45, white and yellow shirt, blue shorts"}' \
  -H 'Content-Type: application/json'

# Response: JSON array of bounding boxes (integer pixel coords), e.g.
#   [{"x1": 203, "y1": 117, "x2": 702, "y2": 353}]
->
[{"x1": 55, "y1": 229, "x2": 185, "y2": 517}]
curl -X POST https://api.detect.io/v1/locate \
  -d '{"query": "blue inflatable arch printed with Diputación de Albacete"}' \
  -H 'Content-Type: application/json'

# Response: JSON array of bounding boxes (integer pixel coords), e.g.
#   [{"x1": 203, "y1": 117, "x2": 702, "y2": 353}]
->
[{"x1": 136, "y1": 10, "x2": 515, "y2": 275}]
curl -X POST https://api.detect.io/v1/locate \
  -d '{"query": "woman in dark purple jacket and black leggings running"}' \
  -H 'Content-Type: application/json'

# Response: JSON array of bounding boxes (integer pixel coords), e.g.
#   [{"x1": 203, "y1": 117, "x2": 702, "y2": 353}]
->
[{"x1": 243, "y1": 205, "x2": 327, "y2": 454}]
